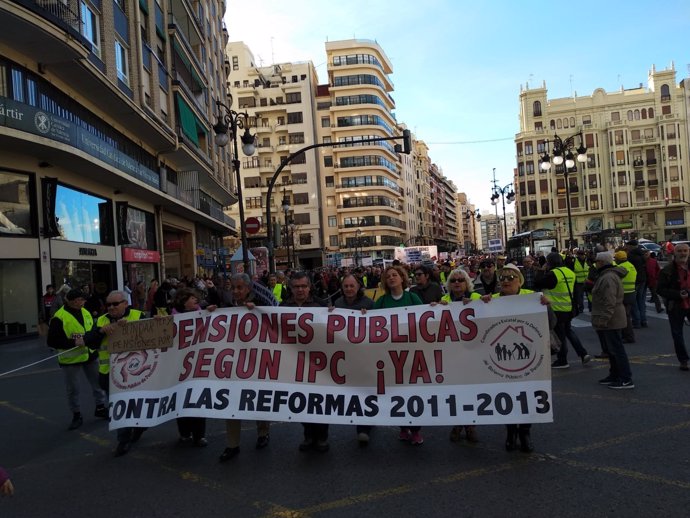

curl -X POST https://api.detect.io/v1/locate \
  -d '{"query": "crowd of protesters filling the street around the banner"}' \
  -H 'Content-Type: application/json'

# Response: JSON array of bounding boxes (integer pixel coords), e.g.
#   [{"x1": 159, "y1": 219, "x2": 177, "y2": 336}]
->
[{"x1": 43, "y1": 241, "x2": 690, "y2": 470}]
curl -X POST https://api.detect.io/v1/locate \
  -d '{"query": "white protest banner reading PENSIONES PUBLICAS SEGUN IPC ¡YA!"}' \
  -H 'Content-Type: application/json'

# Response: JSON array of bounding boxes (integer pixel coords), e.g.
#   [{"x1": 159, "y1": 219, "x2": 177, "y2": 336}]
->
[{"x1": 110, "y1": 294, "x2": 553, "y2": 429}]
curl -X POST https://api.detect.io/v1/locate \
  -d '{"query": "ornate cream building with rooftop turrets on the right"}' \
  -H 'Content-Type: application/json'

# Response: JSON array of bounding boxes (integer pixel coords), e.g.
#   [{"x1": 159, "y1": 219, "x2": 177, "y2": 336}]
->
[{"x1": 515, "y1": 65, "x2": 690, "y2": 247}]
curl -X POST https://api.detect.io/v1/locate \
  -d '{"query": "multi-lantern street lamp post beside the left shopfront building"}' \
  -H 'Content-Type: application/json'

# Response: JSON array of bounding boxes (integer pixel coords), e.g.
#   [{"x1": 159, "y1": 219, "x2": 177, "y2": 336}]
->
[{"x1": 213, "y1": 95, "x2": 256, "y2": 274}]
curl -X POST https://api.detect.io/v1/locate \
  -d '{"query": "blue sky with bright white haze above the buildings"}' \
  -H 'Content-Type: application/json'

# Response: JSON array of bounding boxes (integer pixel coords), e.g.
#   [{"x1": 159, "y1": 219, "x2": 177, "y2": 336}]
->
[{"x1": 225, "y1": 0, "x2": 690, "y2": 212}]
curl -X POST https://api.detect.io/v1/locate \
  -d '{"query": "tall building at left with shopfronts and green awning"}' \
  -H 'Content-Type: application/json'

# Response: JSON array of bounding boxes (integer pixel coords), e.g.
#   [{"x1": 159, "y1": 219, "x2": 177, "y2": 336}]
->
[{"x1": 0, "y1": 0, "x2": 236, "y2": 338}]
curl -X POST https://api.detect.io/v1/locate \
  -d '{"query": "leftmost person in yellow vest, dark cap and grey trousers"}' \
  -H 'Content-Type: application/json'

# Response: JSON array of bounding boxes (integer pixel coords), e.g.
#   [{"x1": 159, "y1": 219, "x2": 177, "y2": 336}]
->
[{"x1": 47, "y1": 289, "x2": 108, "y2": 430}]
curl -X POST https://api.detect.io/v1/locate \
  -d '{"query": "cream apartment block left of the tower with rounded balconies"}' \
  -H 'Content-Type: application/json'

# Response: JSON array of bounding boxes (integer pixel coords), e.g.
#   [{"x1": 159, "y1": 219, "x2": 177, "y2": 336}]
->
[{"x1": 226, "y1": 42, "x2": 322, "y2": 269}]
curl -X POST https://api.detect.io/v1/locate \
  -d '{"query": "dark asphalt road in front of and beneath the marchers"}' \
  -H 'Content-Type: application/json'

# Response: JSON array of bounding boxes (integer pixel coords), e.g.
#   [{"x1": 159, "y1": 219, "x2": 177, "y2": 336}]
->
[{"x1": 0, "y1": 305, "x2": 690, "y2": 518}]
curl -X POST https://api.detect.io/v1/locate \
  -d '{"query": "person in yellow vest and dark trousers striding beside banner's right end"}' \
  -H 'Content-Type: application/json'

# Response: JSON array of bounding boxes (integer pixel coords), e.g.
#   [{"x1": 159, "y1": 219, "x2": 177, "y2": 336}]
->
[{"x1": 535, "y1": 252, "x2": 592, "y2": 369}]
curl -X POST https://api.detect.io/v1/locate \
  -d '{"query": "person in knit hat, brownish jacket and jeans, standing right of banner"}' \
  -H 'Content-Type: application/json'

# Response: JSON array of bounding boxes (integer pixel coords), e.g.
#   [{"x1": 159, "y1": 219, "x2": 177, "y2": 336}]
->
[{"x1": 591, "y1": 252, "x2": 635, "y2": 390}]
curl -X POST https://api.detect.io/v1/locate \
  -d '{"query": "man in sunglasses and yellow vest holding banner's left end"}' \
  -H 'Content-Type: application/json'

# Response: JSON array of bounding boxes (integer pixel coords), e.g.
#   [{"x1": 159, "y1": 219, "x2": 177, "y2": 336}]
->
[{"x1": 86, "y1": 291, "x2": 146, "y2": 457}]
